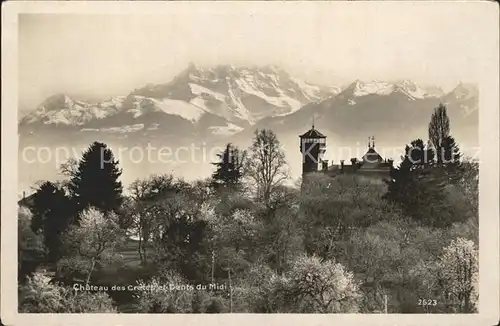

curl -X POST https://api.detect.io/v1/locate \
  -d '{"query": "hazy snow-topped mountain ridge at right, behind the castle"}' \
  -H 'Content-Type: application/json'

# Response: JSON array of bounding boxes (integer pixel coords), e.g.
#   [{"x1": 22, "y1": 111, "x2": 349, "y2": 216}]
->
[{"x1": 242, "y1": 80, "x2": 478, "y2": 149}]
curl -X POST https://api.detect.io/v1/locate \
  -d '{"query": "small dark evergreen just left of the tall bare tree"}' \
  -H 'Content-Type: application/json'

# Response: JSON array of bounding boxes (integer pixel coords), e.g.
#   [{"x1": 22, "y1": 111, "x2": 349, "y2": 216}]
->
[{"x1": 212, "y1": 143, "x2": 246, "y2": 190}]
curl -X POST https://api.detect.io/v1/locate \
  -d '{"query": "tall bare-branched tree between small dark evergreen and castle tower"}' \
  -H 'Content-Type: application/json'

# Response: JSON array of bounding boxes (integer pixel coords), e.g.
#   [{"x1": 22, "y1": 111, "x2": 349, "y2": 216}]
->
[{"x1": 247, "y1": 129, "x2": 288, "y2": 205}]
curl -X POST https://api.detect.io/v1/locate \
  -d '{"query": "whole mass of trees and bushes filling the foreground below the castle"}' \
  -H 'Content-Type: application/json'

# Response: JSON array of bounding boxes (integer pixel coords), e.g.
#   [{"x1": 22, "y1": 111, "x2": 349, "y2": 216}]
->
[{"x1": 19, "y1": 106, "x2": 478, "y2": 313}]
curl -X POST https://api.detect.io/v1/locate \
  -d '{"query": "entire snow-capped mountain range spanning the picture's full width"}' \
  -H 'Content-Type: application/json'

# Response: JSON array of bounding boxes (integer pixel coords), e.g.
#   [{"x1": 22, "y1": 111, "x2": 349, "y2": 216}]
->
[{"x1": 18, "y1": 64, "x2": 479, "y2": 191}]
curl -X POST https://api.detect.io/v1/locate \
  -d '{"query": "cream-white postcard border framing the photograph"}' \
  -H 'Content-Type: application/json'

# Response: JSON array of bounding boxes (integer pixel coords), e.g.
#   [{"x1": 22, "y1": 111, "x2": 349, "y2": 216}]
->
[{"x1": 0, "y1": 1, "x2": 500, "y2": 326}]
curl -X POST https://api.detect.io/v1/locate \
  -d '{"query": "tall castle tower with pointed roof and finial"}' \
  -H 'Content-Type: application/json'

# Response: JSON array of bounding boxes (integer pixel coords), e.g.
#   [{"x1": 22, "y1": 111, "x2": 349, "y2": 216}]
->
[{"x1": 299, "y1": 123, "x2": 326, "y2": 174}]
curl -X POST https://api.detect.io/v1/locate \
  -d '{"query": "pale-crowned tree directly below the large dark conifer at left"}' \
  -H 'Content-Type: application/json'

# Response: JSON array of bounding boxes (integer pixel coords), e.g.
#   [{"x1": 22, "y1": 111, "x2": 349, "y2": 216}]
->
[{"x1": 58, "y1": 207, "x2": 124, "y2": 284}]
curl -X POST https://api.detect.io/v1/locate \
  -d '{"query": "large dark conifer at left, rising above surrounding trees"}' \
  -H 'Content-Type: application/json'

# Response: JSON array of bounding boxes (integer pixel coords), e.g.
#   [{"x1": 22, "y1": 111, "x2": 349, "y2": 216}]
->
[{"x1": 69, "y1": 142, "x2": 123, "y2": 213}]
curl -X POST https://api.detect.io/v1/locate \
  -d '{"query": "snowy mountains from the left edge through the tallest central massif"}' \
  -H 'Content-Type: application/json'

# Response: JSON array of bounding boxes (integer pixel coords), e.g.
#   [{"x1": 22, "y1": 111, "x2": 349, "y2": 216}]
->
[{"x1": 20, "y1": 65, "x2": 339, "y2": 134}]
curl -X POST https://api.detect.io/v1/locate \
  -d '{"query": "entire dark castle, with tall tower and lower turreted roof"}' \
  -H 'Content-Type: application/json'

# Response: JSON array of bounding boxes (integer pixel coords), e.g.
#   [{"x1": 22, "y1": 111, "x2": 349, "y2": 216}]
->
[{"x1": 299, "y1": 124, "x2": 394, "y2": 180}]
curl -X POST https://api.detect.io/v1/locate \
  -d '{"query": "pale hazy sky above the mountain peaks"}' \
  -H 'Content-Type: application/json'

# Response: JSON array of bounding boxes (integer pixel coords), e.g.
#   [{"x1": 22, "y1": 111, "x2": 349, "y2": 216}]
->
[{"x1": 19, "y1": 3, "x2": 484, "y2": 108}]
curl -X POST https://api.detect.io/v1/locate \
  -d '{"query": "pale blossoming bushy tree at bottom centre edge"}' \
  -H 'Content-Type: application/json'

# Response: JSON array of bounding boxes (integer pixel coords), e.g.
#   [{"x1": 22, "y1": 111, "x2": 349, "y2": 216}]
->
[{"x1": 237, "y1": 255, "x2": 360, "y2": 313}]
